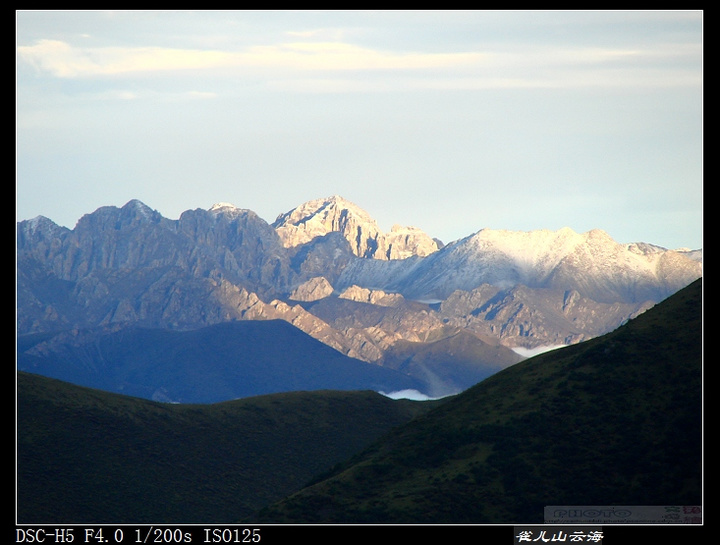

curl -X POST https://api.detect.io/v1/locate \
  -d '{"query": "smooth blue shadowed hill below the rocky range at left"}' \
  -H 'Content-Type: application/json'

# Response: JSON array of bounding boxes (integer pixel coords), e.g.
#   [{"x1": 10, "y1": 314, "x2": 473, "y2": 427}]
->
[{"x1": 17, "y1": 320, "x2": 426, "y2": 403}]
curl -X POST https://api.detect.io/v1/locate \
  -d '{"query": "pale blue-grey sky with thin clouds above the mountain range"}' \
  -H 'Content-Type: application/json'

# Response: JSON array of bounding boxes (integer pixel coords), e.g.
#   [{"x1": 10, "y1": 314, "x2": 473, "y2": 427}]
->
[{"x1": 16, "y1": 10, "x2": 703, "y2": 249}]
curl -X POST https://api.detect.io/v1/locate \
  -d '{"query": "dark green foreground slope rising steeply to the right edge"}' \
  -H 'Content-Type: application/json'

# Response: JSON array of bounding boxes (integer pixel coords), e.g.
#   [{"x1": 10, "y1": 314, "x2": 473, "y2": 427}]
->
[{"x1": 253, "y1": 280, "x2": 703, "y2": 524}]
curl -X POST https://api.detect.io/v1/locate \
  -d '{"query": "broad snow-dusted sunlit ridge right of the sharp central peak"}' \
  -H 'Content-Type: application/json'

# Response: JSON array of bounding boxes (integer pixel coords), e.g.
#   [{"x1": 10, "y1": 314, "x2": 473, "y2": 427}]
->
[{"x1": 336, "y1": 224, "x2": 702, "y2": 302}]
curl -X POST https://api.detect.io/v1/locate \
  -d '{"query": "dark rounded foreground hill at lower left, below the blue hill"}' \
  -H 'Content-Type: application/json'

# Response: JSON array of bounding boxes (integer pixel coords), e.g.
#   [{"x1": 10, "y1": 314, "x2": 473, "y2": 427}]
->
[{"x1": 17, "y1": 372, "x2": 442, "y2": 524}]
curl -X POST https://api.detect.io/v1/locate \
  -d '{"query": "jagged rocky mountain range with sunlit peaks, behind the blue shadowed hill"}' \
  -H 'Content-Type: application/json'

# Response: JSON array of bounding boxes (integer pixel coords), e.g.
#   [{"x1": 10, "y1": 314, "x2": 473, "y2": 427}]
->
[{"x1": 17, "y1": 197, "x2": 702, "y2": 393}]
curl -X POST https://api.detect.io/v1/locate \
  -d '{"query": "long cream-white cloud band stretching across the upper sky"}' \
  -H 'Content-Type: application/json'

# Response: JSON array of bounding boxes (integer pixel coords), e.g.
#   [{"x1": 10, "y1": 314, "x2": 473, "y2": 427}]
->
[{"x1": 18, "y1": 31, "x2": 700, "y2": 90}]
